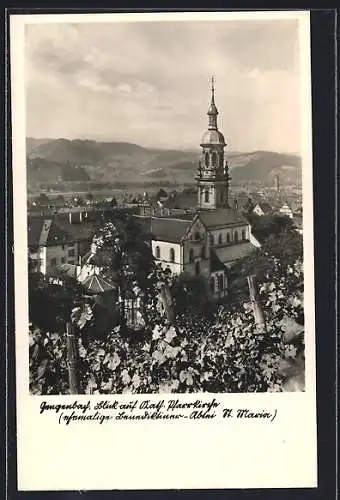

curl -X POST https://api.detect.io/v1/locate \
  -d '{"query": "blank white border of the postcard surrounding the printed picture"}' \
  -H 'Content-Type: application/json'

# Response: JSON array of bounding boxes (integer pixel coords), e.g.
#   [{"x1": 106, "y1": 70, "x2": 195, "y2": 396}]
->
[{"x1": 10, "y1": 11, "x2": 317, "y2": 491}]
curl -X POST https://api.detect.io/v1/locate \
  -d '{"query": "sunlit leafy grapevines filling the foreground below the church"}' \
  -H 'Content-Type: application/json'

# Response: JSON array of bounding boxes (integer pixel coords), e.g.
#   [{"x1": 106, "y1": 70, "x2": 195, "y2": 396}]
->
[{"x1": 30, "y1": 261, "x2": 304, "y2": 394}]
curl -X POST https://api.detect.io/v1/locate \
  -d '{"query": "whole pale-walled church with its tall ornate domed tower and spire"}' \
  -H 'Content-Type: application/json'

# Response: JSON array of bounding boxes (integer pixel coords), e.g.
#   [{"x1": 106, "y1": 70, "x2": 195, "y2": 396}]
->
[{"x1": 150, "y1": 81, "x2": 258, "y2": 298}]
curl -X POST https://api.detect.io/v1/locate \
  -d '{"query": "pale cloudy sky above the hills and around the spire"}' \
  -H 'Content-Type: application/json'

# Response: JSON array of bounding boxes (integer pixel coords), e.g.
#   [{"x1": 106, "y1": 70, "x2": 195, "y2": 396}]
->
[{"x1": 25, "y1": 16, "x2": 301, "y2": 153}]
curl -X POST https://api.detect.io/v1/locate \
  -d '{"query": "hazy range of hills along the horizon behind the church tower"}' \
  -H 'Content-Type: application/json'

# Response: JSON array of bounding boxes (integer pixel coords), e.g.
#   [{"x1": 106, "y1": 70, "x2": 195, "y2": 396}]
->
[{"x1": 26, "y1": 138, "x2": 301, "y2": 189}]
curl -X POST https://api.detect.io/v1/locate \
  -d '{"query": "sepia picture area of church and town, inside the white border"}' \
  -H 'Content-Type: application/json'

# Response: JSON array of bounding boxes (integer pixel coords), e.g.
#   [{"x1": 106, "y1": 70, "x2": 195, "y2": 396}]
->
[{"x1": 25, "y1": 12, "x2": 312, "y2": 395}]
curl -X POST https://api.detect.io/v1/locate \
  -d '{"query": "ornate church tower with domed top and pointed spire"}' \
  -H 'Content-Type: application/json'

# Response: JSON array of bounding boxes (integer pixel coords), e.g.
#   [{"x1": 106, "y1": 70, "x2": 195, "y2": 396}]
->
[{"x1": 195, "y1": 78, "x2": 230, "y2": 210}]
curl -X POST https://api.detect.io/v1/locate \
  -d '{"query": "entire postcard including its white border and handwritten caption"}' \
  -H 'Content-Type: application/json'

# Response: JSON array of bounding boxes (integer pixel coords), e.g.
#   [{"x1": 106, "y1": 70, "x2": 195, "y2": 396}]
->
[{"x1": 11, "y1": 11, "x2": 317, "y2": 491}]
